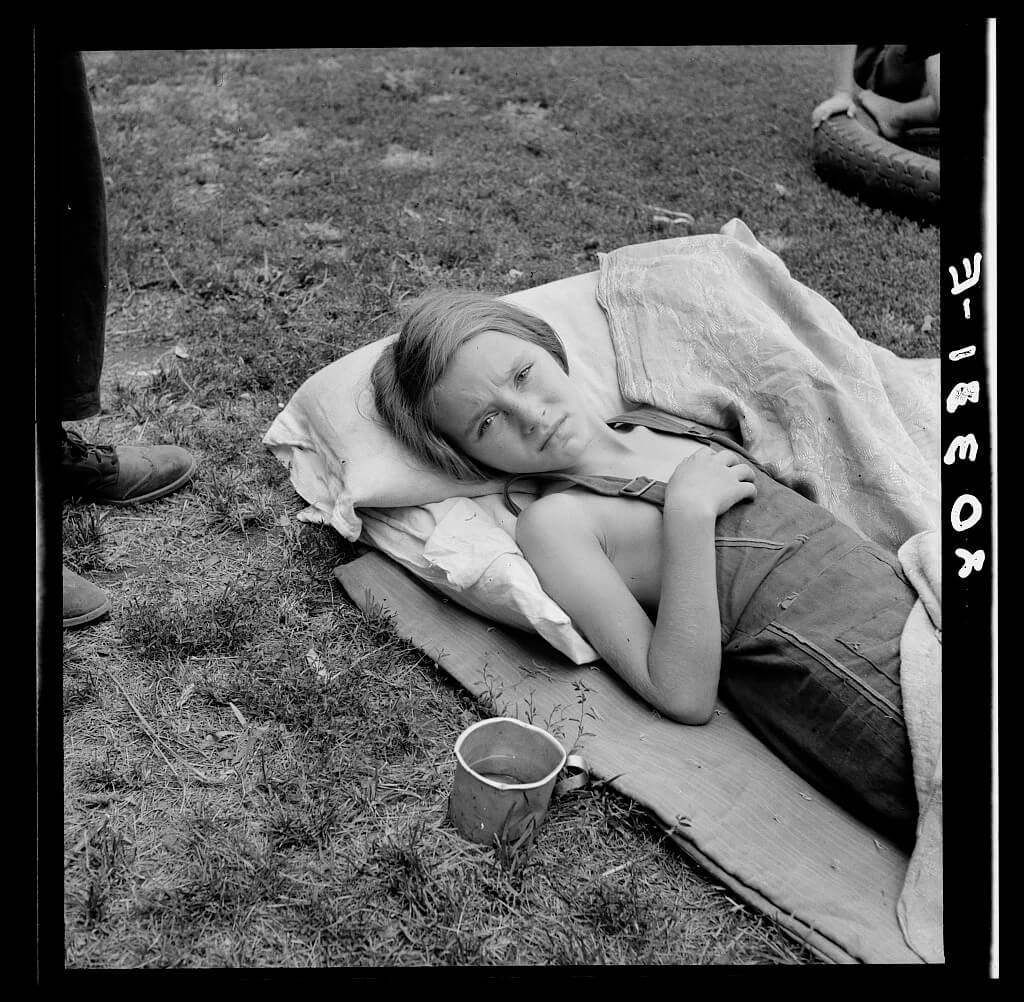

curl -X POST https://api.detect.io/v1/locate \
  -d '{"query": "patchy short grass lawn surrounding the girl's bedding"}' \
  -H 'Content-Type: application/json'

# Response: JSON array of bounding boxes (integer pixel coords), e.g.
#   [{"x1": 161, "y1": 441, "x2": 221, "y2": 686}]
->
[{"x1": 56, "y1": 46, "x2": 939, "y2": 968}]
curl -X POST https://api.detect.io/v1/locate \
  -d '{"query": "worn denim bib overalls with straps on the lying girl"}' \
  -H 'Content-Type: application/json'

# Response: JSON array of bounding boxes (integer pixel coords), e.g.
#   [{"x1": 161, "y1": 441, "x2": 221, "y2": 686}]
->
[{"x1": 506, "y1": 407, "x2": 918, "y2": 846}]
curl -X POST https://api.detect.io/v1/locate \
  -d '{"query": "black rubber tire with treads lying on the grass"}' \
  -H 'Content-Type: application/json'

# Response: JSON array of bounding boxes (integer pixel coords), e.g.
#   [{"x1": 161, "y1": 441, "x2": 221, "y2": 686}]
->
[{"x1": 813, "y1": 115, "x2": 940, "y2": 222}]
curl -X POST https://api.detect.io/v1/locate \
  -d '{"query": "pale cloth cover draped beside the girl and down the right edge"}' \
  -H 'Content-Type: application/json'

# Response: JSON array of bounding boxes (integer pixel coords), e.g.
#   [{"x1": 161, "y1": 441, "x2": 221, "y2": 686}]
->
[{"x1": 597, "y1": 219, "x2": 943, "y2": 963}]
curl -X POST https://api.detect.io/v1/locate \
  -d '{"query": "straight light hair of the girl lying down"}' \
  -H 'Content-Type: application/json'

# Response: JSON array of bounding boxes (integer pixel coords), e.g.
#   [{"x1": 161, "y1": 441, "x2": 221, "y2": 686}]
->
[{"x1": 371, "y1": 289, "x2": 569, "y2": 480}]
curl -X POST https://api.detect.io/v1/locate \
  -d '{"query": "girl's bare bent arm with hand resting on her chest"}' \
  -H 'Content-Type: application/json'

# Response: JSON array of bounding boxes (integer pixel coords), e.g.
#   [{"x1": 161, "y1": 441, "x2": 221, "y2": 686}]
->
[{"x1": 516, "y1": 450, "x2": 755, "y2": 724}]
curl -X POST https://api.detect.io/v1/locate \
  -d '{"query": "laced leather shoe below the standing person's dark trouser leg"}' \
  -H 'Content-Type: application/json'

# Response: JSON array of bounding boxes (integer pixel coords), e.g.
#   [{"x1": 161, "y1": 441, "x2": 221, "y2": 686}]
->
[{"x1": 60, "y1": 429, "x2": 196, "y2": 505}]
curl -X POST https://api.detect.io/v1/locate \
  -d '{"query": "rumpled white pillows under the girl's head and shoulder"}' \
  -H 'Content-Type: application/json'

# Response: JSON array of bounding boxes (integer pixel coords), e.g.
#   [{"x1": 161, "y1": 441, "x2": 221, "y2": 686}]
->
[{"x1": 263, "y1": 271, "x2": 630, "y2": 664}]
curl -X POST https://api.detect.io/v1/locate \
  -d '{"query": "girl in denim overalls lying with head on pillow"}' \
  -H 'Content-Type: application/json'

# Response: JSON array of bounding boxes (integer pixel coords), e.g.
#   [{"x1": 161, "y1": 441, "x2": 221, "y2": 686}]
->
[{"x1": 374, "y1": 292, "x2": 918, "y2": 845}]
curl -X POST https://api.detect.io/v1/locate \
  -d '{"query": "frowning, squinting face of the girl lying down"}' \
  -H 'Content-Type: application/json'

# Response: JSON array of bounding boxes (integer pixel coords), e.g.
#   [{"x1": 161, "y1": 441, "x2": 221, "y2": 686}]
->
[{"x1": 433, "y1": 331, "x2": 593, "y2": 473}]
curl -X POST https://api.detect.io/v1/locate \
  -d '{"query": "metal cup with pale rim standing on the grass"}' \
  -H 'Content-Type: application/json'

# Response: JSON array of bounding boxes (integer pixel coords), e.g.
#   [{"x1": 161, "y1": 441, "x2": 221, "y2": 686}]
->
[{"x1": 449, "y1": 716, "x2": 566, "y2": 845}]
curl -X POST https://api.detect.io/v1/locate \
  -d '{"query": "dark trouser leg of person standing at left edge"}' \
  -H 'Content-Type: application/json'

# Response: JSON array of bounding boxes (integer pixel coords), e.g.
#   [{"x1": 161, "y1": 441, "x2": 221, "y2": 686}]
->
[{"x1": 53, "y1": 52, "x2": 108, "y2": 421}]
